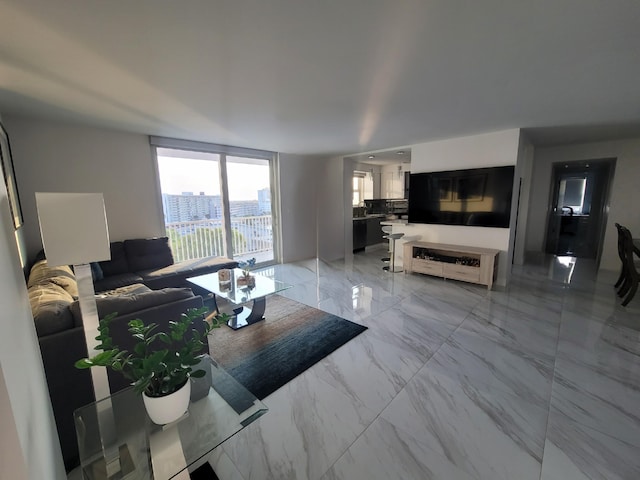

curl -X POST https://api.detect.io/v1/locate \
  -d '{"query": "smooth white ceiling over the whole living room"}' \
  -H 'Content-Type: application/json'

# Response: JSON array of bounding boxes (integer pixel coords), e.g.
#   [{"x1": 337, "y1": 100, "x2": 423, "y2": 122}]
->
[{"x1": 0, "y1": 0, "x2": 640, "y2": 154}]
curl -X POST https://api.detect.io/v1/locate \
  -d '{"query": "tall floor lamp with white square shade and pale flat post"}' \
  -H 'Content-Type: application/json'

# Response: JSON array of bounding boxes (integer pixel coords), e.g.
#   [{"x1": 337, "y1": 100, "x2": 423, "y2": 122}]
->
[{"x1": 36, "y1": 192, "x2": 127, "y2": 478}]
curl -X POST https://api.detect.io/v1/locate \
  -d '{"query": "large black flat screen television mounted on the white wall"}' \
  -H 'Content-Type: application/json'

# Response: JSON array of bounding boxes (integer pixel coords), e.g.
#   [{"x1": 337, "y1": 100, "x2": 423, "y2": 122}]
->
[{"x1": 409, "y1": 166, "x2": 514, "y2": 228}]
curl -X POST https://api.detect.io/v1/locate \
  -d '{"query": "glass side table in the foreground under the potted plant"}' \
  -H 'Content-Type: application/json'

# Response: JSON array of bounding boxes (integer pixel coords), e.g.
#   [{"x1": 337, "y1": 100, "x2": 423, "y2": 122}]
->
[{"x1": 74, "y1": 356, "x2": 267, "y2": 480}]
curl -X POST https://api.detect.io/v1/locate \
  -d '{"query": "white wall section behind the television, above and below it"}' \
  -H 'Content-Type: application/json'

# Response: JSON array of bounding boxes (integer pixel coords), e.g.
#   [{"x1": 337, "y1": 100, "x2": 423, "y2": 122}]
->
[{"x1": 394, "y1": 129, "x2": 520, "y2": 285}]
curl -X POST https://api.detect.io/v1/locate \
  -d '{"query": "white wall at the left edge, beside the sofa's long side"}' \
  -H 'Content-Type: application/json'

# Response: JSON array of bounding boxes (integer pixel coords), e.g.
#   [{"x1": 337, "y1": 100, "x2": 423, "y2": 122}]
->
[{"x1": 0, "y1": 127, "x2": 65, "y2": 480}]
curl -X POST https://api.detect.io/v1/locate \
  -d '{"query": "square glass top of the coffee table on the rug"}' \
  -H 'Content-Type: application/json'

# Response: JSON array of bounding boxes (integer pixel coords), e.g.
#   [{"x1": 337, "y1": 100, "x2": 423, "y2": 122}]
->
[{"x1": 187, "y1": 268, "x2": 292, "y2": 305}]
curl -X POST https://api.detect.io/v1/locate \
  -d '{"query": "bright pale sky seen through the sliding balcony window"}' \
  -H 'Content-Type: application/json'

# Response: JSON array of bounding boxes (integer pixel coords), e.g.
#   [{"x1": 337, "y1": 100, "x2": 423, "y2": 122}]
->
[{"x1": 158, "y1": 156, "x2": 269, "y2": 200}]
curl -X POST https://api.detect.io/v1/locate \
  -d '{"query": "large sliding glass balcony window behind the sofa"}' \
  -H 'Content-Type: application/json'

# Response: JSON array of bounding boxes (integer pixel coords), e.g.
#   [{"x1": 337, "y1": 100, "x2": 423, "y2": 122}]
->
[{"x1": 151, "y1": 137, "x2": 279, "y2": 264}]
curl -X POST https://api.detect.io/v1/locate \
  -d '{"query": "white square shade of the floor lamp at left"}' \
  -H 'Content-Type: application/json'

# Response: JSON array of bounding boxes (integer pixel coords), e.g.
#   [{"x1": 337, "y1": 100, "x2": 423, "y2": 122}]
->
[{"x1": 36, "y1": 192, "x2": 111, "y2": 266}]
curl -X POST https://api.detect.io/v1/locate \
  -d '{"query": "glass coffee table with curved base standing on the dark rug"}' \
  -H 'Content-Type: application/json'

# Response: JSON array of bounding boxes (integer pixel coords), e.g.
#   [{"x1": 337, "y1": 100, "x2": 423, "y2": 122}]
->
[{"x1": 187, "y1": 268, "x2": 292, "y2": 330}]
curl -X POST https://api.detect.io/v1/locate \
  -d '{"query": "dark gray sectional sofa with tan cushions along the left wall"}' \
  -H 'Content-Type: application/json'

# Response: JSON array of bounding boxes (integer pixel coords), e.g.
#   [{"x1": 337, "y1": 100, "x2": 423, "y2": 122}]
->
[{"x1": 27, "y1": 238, "x2": 237, "y2": 470}]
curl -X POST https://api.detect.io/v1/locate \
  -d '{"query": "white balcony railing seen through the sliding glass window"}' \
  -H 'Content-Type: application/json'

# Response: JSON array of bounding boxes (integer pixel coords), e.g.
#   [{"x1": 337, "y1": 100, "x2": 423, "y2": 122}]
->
[{"x1": 165, "y1": 215, "x2": 273, "y2": 262}]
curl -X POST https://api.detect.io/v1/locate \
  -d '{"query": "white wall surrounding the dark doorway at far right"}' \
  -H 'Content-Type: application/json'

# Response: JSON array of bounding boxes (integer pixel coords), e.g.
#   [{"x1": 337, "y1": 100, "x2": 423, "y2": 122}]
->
[{"x1": 526, "y1": 139, "x2": 640, "y2": 270}]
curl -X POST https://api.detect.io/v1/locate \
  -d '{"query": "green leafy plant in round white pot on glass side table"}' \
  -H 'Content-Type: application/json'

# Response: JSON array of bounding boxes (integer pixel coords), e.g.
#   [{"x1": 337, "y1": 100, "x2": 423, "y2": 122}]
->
[{"x1": 75, "y1": 307, "x2": 229, "y2": 424}]
